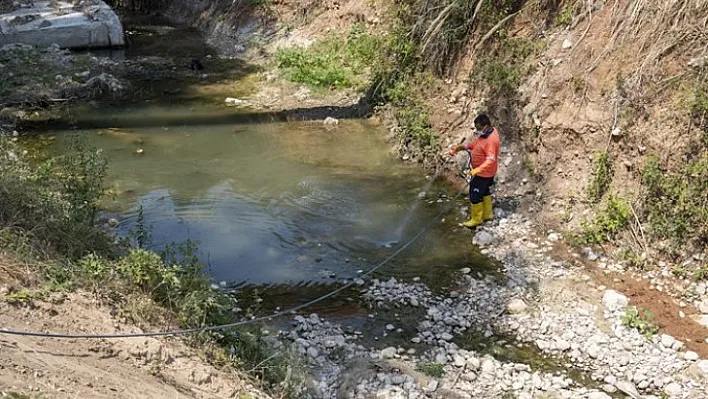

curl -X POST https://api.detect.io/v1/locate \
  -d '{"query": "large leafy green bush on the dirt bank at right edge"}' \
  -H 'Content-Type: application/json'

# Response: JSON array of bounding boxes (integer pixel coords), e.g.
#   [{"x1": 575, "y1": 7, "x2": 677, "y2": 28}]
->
[{"x1": 642, "y1": 155, "x2": 708, "y2": 252}]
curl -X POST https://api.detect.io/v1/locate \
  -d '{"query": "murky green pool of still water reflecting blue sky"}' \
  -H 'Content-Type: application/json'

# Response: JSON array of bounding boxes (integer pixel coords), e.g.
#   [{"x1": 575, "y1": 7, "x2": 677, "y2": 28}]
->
[{"x1": 49, "y1": 105, "x2": 496, "y2": 292}]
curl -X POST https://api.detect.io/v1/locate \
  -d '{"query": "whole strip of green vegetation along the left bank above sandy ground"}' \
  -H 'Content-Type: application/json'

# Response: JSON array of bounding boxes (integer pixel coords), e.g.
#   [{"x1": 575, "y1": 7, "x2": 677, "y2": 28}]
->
[{"x1": 0, "y1": 136, "x2": 304, "y2": 398}]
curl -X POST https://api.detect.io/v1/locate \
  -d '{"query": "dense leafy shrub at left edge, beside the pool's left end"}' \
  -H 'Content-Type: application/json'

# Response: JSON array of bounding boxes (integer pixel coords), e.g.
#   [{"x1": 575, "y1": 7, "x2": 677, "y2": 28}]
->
[{"x1": 0, "y1": 136, "x2": 111, "y2": 259}]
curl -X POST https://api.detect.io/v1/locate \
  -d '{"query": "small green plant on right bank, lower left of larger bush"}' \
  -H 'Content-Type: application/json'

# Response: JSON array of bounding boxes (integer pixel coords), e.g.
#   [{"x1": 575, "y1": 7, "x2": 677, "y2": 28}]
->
[{"x1": 579, "y1": 195, "x2": 631, "y2": 244}]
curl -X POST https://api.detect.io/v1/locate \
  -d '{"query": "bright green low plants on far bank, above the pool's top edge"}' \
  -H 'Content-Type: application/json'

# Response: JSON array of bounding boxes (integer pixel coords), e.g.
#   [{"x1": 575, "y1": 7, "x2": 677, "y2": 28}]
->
[{"x1": 276, "y1": 24, "x2": 382, "y2": 89}]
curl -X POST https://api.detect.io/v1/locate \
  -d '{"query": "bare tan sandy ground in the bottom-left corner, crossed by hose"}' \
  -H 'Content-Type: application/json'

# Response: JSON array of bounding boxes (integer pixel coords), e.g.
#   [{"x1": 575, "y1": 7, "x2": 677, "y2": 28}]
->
[{"x1": 0, "y1": 280, "x2": 266, "y2": 398}]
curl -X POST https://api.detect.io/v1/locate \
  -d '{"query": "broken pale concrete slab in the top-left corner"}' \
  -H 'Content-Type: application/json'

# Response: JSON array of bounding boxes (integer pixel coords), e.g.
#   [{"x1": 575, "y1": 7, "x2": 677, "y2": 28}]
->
[{"x1": 0, "y1": 0, "x2": 125, "y2": 49}]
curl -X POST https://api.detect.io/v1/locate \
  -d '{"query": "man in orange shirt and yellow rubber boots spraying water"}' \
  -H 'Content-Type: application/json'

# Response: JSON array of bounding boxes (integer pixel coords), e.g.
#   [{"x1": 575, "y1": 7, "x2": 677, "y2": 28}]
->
[{"x1": 450, "y1": 114, "x2": 499, "y2": 228}]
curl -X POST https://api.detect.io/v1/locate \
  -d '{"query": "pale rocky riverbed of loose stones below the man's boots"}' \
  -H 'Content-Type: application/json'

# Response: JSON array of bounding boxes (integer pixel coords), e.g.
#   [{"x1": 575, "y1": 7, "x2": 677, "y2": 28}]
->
[{"x1": 281, "y1": 209, "x2": 708, "y2": 399}]
